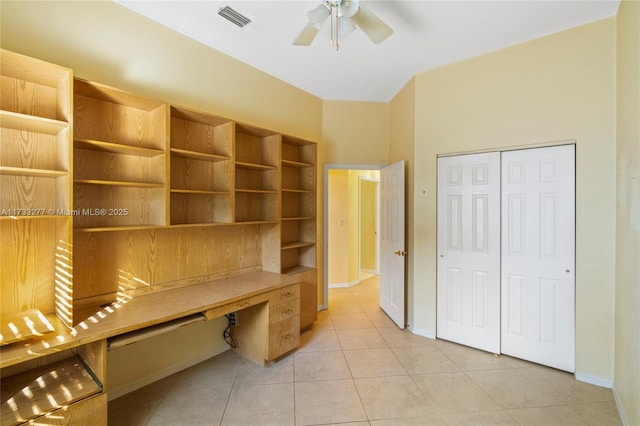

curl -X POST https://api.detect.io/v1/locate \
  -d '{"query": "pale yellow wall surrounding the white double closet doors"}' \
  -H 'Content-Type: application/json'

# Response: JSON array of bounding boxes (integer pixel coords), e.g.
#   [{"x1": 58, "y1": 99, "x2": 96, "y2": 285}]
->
[{"x1": 409, "y1": 18, "x2": 616, "y2": 383}]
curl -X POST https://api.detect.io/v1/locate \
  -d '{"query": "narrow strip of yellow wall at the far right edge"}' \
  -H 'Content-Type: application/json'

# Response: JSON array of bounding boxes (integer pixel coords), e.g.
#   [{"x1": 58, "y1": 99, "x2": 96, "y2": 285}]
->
[{"x1": 614, "y1": 1, "x2": 640, "y2": 425}]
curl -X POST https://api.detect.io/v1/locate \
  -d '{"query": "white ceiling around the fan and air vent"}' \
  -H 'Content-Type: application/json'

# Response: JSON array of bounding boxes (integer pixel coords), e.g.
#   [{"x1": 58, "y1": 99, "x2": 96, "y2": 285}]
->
[{"x1": 115, "y1": 0, "x2": 620, "y2": 102}]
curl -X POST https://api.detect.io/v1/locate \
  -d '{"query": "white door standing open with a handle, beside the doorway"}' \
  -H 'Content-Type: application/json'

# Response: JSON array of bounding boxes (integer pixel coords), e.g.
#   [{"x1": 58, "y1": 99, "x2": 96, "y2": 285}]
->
[{"x1": 380, "y1": 161, "x2": 406, "y2": 328}]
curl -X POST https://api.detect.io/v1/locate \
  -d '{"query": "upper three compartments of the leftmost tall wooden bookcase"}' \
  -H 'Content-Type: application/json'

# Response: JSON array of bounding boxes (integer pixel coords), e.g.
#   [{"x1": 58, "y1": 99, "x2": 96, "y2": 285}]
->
[{"x1": 0, "y1": 50, "x2": 73, "y2": 219}]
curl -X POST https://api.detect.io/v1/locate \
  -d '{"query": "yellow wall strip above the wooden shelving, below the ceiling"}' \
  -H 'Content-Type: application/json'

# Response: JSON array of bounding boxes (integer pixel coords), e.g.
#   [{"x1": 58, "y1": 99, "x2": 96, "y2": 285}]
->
[{"x1": 0, "y1": 0, "x2": 322, "y2": 141}]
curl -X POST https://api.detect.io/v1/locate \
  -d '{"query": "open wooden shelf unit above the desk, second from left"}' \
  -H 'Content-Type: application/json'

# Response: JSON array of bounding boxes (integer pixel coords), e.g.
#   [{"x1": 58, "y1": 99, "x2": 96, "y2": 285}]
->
[{"x1": 73, "y1": 79, "x2": 169, "y2": 231}]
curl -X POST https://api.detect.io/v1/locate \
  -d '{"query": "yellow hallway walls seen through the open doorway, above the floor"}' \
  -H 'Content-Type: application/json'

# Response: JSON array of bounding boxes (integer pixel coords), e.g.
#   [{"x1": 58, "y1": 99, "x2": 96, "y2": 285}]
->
[{"x1": 323, "y1": 165, "x2": 383, "y2": 308}]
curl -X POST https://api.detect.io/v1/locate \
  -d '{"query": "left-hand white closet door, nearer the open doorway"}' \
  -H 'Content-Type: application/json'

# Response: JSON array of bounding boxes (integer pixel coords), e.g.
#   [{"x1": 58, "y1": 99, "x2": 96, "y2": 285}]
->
[{"x1": 437, "y1": 152, "x2": 500, "y2": 353}]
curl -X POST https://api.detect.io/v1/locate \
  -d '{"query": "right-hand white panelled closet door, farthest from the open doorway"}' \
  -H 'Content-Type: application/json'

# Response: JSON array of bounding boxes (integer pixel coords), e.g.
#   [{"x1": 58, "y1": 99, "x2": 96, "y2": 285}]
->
[{"x1": 502, "y1": 145, "x2": 575, "y2": 372}]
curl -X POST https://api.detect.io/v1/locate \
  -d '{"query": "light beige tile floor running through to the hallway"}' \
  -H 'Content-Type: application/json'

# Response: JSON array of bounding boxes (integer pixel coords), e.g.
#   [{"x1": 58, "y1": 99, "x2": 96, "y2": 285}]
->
[{"x1": 109, "y1": 277, "x2": 621, "y2": 426}]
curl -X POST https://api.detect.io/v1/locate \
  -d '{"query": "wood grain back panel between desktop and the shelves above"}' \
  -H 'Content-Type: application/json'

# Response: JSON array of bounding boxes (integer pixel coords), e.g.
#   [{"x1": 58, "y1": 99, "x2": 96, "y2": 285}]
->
[{"x1": 74, "y1": 225, "x2": 262, "y2": 305}]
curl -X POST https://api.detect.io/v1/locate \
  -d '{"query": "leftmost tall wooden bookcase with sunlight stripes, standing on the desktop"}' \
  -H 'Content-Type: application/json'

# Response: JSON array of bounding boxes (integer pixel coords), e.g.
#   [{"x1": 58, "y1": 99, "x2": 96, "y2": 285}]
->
[{"x1": 0, "y1": 50, "x2": 73, "y2": 330}]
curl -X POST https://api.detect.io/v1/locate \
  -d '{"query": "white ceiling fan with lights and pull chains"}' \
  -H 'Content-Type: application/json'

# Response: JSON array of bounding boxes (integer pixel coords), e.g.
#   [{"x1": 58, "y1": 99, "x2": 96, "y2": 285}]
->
[{"x1": 293, "y1": 0, "x2": 393, "y2": 50}]
